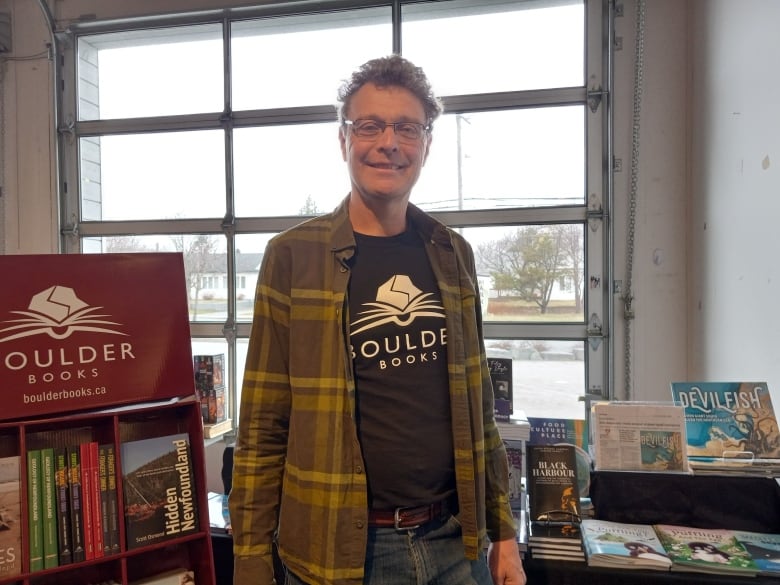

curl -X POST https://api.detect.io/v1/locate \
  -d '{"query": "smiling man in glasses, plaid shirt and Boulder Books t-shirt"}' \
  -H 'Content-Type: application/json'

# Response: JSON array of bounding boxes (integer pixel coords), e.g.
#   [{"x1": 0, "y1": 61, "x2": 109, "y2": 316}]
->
[{"x1": 230, "y1": 56, "x2": 525, "y2": 585}]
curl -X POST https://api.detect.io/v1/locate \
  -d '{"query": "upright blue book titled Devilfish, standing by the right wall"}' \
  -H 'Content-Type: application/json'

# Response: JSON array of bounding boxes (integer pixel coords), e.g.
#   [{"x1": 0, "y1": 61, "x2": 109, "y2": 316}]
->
[{"x1": 671, "y1": 382, "x2": 780, "y2": 460}]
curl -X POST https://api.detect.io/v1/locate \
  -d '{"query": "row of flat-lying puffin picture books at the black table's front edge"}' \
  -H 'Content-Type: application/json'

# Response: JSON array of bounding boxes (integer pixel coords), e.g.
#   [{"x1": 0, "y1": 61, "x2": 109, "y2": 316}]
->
[{"x1": 581, "y1": 519, "x2": 780, "y2": 576}]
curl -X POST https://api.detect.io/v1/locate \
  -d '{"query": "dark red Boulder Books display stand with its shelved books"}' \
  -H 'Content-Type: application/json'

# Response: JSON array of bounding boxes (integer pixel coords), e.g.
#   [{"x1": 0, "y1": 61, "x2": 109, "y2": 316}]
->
[{"x1": 0, "y1": 254, "x2": 215, "y2": 585}]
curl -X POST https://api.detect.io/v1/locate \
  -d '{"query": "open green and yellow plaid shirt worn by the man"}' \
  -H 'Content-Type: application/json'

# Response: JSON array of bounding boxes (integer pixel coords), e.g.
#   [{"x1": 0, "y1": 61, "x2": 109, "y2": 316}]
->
[{"x1": 229, "y1": 200, "x2": 515, "y2": 585}]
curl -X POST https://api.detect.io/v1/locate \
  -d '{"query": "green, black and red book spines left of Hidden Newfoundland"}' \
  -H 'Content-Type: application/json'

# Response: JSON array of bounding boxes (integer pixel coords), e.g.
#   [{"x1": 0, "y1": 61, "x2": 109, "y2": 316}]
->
[{"x1": 27, "y1": 441, "x2": 119, "y2": 572}]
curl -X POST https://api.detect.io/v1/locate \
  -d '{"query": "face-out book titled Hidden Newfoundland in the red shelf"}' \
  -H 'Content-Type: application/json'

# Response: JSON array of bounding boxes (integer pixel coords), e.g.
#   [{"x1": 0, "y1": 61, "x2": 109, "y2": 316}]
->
[{"x1": 121, "y1": 433, "x2": 198, "y2": 549}]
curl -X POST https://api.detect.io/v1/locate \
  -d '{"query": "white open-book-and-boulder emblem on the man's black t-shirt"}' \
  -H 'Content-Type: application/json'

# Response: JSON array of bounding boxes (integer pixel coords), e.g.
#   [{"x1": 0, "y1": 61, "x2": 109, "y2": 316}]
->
[{"x1": 352, "y1": 274, "x2": 445, "y2": 335}]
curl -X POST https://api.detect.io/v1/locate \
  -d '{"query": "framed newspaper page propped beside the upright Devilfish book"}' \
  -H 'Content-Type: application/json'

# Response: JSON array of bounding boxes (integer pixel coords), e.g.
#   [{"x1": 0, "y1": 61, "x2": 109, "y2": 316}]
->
[{"x1": 591, "y1": 402, "x2": 690, "y2": 473}]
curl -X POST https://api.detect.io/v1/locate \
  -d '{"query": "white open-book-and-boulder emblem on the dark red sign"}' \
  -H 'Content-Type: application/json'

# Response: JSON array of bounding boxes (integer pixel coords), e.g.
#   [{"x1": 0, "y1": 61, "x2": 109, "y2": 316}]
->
[{"x1": 0, "y1": 285, "x2": 127, "y2": 343}]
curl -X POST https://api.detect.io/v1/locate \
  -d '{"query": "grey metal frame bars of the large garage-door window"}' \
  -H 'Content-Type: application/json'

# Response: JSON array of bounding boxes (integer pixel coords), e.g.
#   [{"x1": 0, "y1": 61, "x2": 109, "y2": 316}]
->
[{"x1": 56, "y1": 0, "x2": 614, "y2": 422}]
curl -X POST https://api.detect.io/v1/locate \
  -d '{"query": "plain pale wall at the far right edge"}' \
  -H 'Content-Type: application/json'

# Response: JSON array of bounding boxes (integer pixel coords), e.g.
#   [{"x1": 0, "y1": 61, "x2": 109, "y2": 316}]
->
[{"x1": 688, "y1": 0, "x2": 780, "y2": 392}]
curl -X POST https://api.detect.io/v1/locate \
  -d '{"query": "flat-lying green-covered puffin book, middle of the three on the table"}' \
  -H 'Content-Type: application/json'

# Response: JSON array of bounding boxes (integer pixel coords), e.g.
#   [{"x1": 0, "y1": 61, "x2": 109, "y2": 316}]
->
[{"x1": 653, "y1": 524, "x2": 758, "y2": 575}]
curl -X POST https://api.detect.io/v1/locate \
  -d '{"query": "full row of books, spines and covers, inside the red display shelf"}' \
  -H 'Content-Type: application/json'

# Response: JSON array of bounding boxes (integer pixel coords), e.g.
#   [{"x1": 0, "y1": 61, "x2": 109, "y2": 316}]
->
[{"x1": 0, "y1": 433, "x2": 199, "y2": 579}]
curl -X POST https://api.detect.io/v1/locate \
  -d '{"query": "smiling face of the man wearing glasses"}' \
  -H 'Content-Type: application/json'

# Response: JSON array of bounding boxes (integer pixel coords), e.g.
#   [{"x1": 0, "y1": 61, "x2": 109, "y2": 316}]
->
[{"x1": 339, "y1": 83, "x2": 431, "y2": 206}]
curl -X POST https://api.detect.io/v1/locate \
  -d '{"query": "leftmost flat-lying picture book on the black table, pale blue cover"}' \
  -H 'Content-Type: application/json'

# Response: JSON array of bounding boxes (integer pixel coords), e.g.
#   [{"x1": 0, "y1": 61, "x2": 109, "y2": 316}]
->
[{"x1": 580, "y1": 518, "x2": 672, "y2": 571}]
